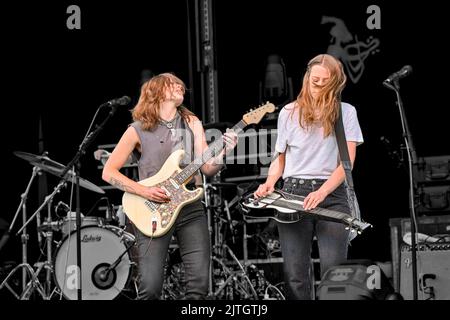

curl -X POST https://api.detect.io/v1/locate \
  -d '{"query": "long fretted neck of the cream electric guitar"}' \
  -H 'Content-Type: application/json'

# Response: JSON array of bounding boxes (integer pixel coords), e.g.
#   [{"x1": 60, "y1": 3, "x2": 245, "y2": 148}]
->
[{"x1": 175, "y1": 120, "x2": 247, "y2": 184}]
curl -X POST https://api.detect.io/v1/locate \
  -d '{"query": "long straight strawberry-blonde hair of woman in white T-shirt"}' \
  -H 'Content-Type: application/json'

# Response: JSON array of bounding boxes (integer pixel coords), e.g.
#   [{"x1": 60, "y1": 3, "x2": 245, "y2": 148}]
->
[{"x1": 296, "y1": 54, "x2": 347, "y2": 137}]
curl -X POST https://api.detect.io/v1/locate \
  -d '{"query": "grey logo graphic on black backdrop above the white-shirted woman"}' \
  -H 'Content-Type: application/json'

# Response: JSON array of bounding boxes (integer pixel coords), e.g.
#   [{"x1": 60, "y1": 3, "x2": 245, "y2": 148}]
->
[{"x1": 321, "y1": 16, "x2": 380, "y2": 83}]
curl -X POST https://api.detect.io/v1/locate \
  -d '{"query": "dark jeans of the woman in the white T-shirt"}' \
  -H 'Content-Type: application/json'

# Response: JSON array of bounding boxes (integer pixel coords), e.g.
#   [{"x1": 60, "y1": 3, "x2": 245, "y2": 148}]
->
[{"x1": 277, "y1": 178, "x2": 350, "y2": 300}]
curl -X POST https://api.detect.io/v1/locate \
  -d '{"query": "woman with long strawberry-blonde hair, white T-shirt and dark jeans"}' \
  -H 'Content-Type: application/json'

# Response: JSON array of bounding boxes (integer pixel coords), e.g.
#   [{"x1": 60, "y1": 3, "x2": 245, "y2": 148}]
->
[{"x1": 255, "y1": 54, "x2": 363, "y2": 300}]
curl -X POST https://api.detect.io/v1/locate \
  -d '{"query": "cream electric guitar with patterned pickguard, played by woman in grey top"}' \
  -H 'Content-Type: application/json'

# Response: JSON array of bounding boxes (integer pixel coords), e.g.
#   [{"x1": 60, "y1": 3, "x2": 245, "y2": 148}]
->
[{"x1": 122, "y1": 102, "x2": 276, "y2": 237}]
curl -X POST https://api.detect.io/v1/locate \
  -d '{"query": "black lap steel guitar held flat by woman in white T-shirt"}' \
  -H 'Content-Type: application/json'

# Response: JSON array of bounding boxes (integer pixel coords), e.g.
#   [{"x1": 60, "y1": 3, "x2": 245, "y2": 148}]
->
[{"x1": 242, "y1": 190, "x2": 372, "y2": 234}]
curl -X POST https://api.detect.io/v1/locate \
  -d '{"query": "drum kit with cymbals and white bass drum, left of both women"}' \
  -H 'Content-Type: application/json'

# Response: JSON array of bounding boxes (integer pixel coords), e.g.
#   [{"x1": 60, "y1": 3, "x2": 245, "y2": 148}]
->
[{"x1": 0, "y1": 151, "x2": 135, "y2": 300}]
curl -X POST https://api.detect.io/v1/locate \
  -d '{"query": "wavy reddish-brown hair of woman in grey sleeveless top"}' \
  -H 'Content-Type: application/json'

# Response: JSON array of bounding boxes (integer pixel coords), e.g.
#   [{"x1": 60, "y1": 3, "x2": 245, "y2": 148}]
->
[{"x1": 131, "y1": 73, "x2": 194, "y2": 130}]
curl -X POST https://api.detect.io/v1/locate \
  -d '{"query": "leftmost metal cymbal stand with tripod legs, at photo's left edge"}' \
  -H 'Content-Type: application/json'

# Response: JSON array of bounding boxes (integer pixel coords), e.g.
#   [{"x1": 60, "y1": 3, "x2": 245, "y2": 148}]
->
[{"x1": 0, "y1": 166, "x2": 48, "y2": 300}]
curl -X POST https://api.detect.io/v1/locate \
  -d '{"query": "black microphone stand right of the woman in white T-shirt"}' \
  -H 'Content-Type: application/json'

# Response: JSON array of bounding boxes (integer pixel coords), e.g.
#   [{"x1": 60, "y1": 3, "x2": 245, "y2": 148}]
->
[{"x1": 383, "y1": 79, "x2": 418, "y2": 300}]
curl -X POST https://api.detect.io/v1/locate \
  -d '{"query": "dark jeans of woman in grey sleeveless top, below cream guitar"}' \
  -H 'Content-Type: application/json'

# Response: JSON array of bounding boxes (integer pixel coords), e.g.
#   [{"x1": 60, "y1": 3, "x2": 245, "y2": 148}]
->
[{"x1": 129, "y1": 201, "x2": 210, "y2": 300}]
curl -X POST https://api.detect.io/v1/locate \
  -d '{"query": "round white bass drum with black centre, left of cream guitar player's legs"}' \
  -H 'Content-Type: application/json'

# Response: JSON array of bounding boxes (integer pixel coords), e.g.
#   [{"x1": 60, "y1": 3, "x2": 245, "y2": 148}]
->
[{"x1": 54, "y1": 226, "x2": 134, "y2": 300}]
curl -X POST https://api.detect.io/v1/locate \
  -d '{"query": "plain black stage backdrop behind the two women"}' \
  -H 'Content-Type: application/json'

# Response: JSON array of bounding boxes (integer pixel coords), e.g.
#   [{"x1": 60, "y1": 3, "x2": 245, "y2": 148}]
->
[{"x1": 0, "y1": 0, "x2": 450, "y2": 270}]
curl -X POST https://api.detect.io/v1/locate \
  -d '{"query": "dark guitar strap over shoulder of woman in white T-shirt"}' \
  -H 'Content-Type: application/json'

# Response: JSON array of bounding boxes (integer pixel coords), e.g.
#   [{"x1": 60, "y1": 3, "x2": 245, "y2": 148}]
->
[{"x1": 334, "y1": 105, "x2": 361, "y2": 241}]
